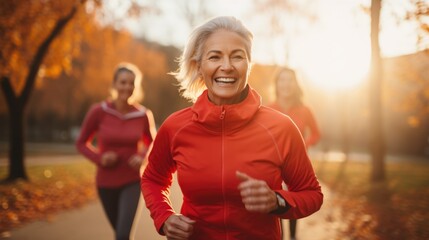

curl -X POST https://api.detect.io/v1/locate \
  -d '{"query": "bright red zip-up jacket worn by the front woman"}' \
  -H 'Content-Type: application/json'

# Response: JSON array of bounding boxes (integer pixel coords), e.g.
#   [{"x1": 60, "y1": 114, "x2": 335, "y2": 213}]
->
[{"x1": 141, "y1": 87, "x2": 323, "y2": 240}]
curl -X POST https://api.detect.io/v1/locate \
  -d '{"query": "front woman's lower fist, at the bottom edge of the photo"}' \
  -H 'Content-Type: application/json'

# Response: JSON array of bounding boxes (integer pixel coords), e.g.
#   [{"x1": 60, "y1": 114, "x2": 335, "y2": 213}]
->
[{"x1": 162, "y1": 214, "x2": 195, "y2": 240}]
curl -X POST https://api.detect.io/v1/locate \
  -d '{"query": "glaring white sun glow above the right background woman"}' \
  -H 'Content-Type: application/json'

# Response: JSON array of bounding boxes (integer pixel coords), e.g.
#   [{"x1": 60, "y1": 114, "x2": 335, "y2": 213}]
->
[{"x1": 292, "y1": 26, "x2": 370, "y2": 91}]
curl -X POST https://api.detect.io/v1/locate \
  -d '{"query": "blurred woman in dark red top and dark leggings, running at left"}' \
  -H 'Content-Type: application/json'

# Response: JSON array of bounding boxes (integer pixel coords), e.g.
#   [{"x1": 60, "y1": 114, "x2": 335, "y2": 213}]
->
[{"x1": 76, "y1": 63, "x2": 156, "y2": 240}]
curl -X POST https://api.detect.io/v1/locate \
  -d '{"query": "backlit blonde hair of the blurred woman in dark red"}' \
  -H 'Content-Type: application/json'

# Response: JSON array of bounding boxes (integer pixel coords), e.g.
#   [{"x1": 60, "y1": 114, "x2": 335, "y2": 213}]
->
[{"x1": 110, "y1": 62, "x2": 144, "y2": 104}]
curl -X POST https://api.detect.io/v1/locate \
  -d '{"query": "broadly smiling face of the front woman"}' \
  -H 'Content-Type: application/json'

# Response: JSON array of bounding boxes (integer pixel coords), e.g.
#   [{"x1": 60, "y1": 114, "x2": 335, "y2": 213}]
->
[{"x1": 199, "y1": 29, "x2": 250, "y2": 105}]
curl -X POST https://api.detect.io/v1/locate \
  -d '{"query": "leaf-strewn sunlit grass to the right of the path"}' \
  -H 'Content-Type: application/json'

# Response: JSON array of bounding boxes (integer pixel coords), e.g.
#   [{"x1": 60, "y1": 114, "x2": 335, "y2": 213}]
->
[{"x1": 314, "y1": 159, "x2": 429, "y2": 240}]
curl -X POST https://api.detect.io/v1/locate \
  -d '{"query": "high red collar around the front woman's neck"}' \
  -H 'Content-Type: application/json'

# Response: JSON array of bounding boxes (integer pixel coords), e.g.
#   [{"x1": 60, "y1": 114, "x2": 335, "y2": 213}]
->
[{"x1": 192, "y1": 85, "x2": 261, "y2": 132}]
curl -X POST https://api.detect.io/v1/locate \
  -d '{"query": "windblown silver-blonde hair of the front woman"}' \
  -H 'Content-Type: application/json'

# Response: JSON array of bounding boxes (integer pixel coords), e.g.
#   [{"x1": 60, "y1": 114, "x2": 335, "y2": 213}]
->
[{"x1": 170, "y1": 16, "x2": 253, "y2": 102}]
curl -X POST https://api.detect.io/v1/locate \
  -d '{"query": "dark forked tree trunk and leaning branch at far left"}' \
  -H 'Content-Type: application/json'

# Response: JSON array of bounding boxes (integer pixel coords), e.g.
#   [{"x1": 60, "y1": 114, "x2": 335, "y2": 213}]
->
[{"x1": 1, "y1": 6, "x2": 77, "y2": 182}]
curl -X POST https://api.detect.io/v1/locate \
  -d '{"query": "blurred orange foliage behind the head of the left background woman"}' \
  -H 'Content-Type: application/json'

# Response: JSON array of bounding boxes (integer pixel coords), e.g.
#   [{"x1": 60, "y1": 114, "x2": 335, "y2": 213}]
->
[{"x1": 24, "y1": 18, "x2": 169, "y2": 122}]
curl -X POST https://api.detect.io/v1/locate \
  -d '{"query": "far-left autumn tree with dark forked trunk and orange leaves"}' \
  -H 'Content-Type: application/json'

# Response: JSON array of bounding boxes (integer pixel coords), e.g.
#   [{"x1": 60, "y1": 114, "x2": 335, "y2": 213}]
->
[{"x1": 0, "y1": 1, "x2": 90, "y2": 181}]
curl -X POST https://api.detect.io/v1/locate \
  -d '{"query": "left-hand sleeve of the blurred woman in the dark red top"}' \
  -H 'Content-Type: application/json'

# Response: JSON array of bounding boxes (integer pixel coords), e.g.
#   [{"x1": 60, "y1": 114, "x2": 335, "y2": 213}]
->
[{"x1": 76, "y1": 105, "x2": 102, "y2": 166}]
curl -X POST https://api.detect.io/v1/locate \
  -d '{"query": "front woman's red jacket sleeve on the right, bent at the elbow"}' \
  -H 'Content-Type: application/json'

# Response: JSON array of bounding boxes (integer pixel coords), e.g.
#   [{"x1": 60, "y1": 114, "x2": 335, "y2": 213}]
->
[{"x1": 276, "y1": 120, "x2": 323, "y2": 219}]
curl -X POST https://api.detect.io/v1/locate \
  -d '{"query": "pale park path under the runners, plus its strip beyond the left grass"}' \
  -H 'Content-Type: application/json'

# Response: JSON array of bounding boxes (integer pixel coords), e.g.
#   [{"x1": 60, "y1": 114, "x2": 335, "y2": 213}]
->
[{"x1": 0, "y1": 156, "x2": 344, "y2": 240}]
